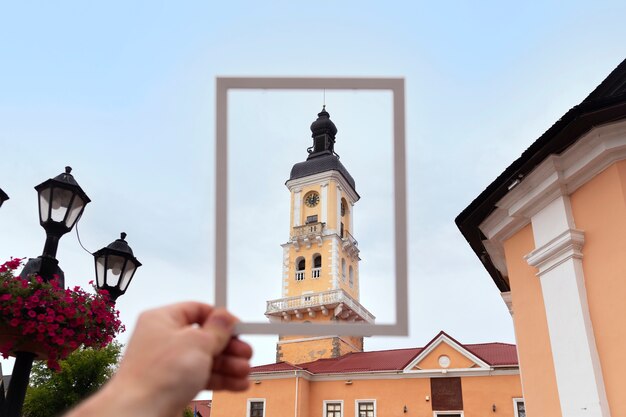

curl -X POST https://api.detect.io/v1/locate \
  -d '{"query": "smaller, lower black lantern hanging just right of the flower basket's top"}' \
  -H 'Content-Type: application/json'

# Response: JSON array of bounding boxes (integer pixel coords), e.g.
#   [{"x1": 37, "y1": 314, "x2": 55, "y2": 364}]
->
[{"x1": 93, "y1": 232, "x2": 141, "y2": 302}]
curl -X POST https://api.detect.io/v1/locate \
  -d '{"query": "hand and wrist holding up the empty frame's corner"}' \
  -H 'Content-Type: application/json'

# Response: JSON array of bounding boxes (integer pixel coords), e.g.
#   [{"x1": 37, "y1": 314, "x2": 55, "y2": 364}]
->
[{"x1": 68, "y1": 302, "x2": 252, "y2": 417}]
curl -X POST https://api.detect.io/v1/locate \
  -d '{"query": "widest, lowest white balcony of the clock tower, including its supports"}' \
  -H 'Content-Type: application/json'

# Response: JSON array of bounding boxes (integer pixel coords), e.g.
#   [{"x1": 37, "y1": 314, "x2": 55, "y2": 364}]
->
[{"x1": 265, "y1": 289, "x2": 376, "y2": 324}]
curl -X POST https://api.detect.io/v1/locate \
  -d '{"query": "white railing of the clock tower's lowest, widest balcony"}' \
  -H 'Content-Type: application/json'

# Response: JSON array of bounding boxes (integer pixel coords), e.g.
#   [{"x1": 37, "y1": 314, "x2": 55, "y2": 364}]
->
[{"x1": 265, "y1": 289, "x2": 376, "y2": 323}]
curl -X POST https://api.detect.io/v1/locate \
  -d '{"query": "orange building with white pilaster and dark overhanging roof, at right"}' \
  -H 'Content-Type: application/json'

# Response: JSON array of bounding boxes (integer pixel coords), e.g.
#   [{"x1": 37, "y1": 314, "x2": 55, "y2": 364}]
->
[{"x1": 456, "y1": 61, "x2": 626, "y2": 417}]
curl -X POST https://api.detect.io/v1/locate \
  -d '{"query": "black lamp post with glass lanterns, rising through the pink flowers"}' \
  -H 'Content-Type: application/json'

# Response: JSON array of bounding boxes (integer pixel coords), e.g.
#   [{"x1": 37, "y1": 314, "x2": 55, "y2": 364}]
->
[{"x1": 0, "y1": 167, "x2": 141, "y2": 417}]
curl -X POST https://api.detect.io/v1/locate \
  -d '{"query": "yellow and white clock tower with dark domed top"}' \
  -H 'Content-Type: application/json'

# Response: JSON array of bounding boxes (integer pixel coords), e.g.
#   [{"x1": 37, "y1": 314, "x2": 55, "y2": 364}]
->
[{"x1": 265, "y1": 107, "x2": 374, "y2": 363}]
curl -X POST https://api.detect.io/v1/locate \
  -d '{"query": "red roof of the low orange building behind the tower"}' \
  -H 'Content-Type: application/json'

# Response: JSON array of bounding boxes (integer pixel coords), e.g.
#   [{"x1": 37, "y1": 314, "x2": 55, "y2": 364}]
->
[{"x1": 252, "y1": 332, "x2": 518, "y2": 374}]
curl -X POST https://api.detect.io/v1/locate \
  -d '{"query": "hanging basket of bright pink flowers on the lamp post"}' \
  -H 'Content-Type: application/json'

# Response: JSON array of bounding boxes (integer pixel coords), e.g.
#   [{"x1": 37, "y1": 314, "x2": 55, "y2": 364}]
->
[{"x1": 0, "y1": 259, "x2": 124, "y2": 369}]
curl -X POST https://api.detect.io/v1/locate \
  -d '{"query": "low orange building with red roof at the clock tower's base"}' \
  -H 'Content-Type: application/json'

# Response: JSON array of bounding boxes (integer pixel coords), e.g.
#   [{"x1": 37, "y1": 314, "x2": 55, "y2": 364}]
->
[{"x1": 212, "y1": 332, "x2": 526, "y2": 417}]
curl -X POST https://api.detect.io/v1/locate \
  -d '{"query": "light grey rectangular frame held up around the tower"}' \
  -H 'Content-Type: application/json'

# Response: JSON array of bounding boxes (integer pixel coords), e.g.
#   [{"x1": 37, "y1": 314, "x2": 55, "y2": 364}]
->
[{"x1": 214, "y1": 77, "x2": 409, "y2": 336}]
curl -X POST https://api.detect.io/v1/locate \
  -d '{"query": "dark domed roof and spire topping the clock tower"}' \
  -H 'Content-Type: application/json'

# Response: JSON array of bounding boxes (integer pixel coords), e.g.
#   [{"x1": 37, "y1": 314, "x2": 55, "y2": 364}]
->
[{"x1": 289, "y1": 106, "x2": 356, "y2": 192}]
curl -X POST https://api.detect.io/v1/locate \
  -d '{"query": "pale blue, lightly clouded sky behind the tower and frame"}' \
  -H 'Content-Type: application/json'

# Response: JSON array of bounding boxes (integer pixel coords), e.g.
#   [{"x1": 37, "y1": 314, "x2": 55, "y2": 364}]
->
[{"x1": 0, "y1": 1, "x2": 626, "y2": 394}]
